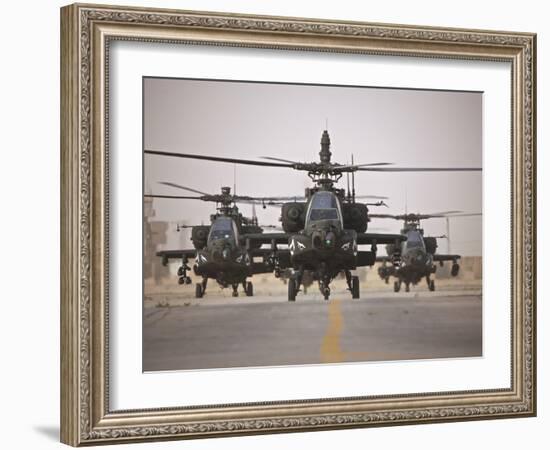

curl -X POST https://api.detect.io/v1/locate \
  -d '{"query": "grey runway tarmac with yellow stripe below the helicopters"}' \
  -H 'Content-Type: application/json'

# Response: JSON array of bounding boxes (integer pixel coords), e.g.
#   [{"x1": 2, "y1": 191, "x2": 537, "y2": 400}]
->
[{"x1": 143, "y1": 291, "x2": 482, "y2": 371}]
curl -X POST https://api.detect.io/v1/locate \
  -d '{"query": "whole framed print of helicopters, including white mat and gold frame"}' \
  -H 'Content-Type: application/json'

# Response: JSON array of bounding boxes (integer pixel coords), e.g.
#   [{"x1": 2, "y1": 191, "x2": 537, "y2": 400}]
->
[{"x1": 61, "y1": 5, "x2": 536, "y2": 446}]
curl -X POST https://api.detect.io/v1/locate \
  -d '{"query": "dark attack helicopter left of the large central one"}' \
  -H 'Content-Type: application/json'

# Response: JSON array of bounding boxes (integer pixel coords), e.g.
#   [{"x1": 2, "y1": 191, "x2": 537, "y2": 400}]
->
[{"x1": 146, "y1": 182, "x2": 294, "y2": 298}]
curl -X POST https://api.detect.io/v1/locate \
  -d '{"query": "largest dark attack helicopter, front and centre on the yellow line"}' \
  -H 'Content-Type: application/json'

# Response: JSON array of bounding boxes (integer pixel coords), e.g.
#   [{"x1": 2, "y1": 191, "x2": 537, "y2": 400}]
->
[{"x1": 145, "y1": 130, "x2": 481, "y2": 301}]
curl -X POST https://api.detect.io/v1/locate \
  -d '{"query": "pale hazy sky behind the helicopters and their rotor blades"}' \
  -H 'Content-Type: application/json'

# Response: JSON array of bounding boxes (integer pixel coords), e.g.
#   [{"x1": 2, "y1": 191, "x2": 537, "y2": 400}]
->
[{"x1": 144, "y1": 78, "x2": 483, "y2": 255}]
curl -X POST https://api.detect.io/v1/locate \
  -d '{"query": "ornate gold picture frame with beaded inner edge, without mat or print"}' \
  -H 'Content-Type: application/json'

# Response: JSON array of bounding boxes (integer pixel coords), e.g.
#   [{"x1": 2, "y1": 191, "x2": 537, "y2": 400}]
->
[{"x1": 61, "y1": 4, "x2": 536, "y2": 446}]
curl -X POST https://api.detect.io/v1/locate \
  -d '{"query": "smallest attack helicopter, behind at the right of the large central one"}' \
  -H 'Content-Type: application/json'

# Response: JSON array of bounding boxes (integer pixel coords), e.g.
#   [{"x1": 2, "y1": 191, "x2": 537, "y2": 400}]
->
[{"x1": 370, "y1": 211, "x2": 480, "y2": 292}]
